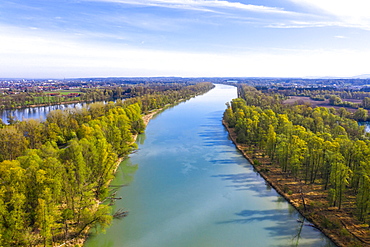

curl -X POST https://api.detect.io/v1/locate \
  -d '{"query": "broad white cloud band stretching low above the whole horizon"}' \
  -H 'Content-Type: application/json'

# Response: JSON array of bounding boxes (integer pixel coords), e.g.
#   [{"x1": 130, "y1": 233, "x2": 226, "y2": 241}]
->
[{"x1": 0, "y1": 25, "x2": 370, "y2": 77}]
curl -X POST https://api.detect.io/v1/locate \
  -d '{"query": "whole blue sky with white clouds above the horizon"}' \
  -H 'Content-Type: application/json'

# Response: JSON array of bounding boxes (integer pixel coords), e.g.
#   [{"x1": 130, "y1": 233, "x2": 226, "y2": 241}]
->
[{"x1": 0, "y1": 0, "x2": 370, "y2": 78}]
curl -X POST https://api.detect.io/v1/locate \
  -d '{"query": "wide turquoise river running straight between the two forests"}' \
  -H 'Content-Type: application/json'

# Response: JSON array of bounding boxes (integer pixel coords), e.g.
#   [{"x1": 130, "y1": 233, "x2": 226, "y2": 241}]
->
[{"x1": 85, "y1": 85, "x2": 334, "y2": 247}]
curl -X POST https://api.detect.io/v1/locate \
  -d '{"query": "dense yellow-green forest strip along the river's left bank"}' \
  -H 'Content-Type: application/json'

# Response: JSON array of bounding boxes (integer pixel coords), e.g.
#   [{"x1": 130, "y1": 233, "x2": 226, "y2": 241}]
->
[{"x1": 0, "y1": 83, "x2": 213, "y2": 246}]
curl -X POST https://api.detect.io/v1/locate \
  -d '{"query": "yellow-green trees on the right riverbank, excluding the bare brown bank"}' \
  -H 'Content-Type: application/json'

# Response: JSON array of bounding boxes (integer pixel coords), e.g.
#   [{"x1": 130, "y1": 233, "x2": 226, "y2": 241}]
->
[{"x1": 224, "y1": 85, "x2": 370, "y2": 246}]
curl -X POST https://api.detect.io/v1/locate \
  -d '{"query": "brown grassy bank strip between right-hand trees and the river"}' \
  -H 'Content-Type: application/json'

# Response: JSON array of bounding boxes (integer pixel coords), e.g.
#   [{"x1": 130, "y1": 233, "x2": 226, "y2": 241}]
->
[{"x1": 223, "y1": 122, "x2": 370, "y2": 247}]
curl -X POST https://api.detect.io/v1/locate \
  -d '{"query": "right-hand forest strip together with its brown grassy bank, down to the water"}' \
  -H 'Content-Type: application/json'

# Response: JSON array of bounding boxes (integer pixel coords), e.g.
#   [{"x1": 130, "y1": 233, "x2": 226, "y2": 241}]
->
[{"x1": 224, "y1": 85, "x2": 370, "y2": 246}]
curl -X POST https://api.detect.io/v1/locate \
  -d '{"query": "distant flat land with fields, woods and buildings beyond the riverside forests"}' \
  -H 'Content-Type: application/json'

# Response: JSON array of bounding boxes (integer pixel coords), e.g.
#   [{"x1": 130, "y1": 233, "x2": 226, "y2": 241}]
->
[{"x1": 0, "y1": 77, "x2": 370, "y2": 111}]
